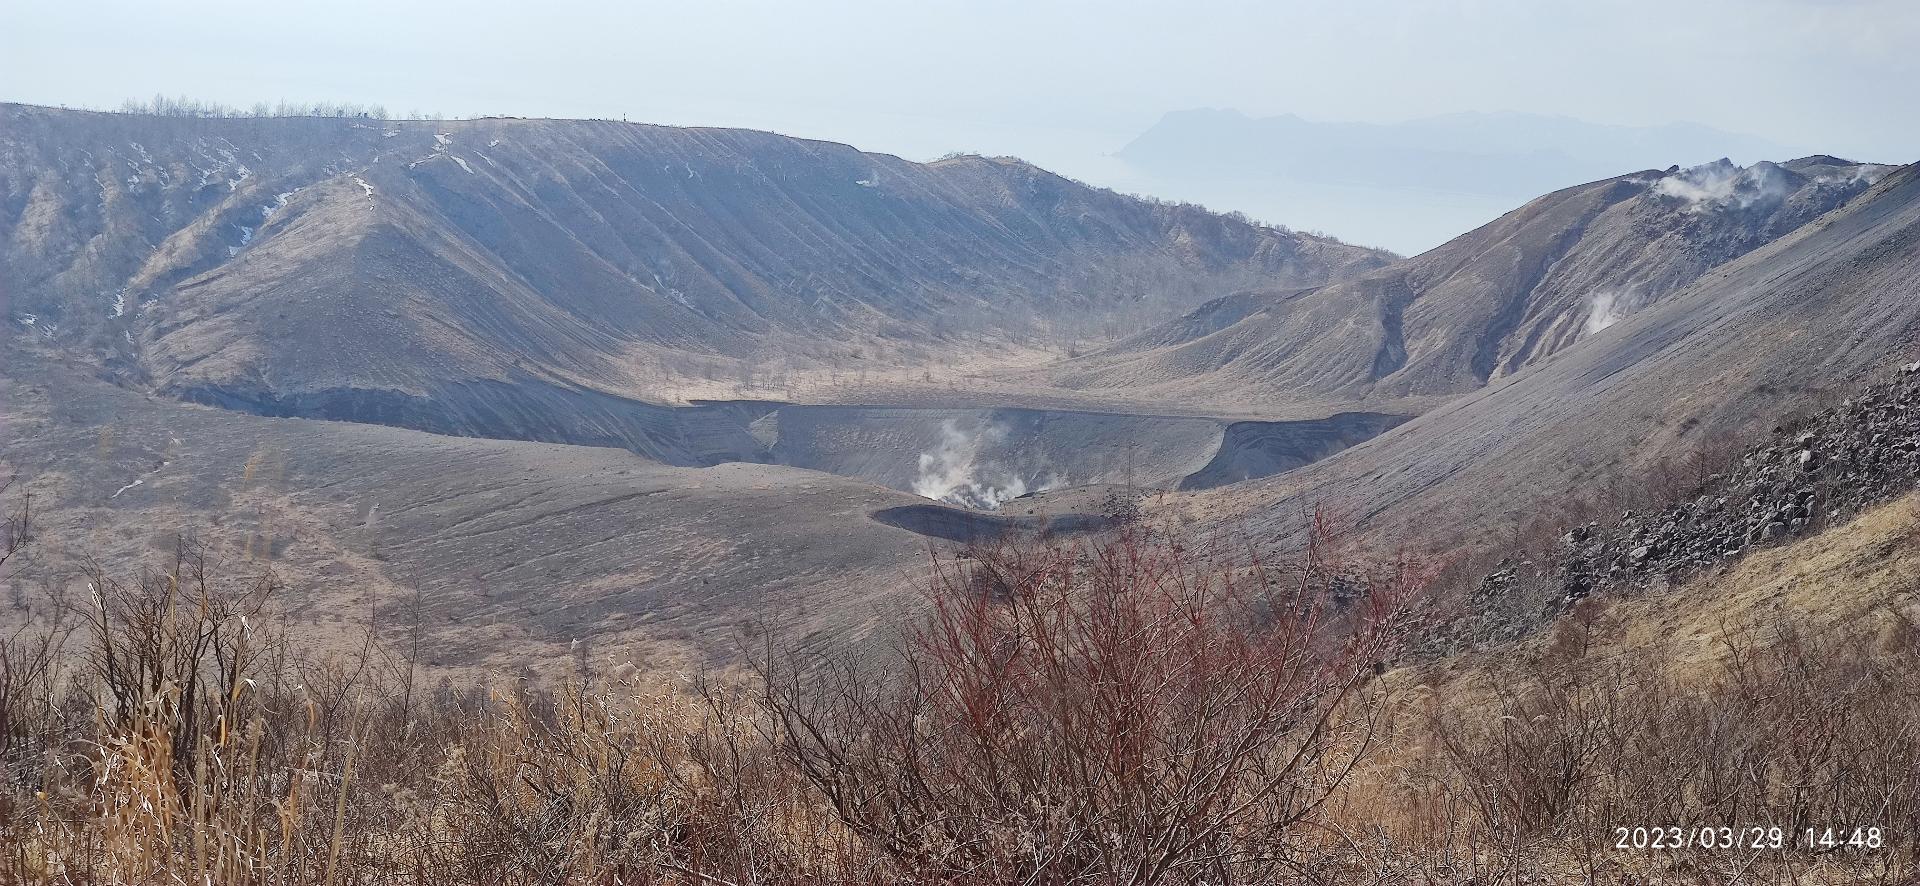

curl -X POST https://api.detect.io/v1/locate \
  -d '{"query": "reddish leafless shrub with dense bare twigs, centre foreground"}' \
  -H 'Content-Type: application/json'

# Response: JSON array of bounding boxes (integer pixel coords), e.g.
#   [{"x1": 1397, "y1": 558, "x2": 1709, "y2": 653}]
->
[{"x1": 758, "y1": 525, "x2": 1417, "y2": 882}]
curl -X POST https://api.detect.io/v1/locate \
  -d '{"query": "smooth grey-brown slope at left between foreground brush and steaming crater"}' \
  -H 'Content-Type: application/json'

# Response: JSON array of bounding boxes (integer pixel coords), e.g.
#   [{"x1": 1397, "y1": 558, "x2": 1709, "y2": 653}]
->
[{"x1": 0, "y1": 344, "x2": 936, "y2": 673}]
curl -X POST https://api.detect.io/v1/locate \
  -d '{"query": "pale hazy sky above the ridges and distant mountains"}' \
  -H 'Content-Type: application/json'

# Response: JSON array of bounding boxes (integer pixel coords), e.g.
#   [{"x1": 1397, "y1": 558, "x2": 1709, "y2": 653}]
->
[{"x1": 0, "y1": 0, "x2": 1920, "y2": 242}]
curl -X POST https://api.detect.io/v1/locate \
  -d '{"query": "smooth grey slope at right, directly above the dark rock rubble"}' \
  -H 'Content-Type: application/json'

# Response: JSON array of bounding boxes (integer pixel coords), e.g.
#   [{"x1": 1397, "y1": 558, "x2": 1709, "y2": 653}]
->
[{"x1": 1190, "y1": 165, "x2": 1920, "y2": 546}]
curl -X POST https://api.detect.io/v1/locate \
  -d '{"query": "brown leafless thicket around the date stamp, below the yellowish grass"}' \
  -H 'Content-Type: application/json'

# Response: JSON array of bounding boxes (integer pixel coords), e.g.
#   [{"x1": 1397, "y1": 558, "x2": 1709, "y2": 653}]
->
[{"x1": 1413, "y1": 611, "x2": 1920, "y2": 882}]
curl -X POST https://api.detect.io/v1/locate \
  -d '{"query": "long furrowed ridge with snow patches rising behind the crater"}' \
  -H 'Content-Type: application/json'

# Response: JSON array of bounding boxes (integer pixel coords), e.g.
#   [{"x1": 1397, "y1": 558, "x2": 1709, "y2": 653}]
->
[{"x1": 0, "y1": 106, "x2": 1390, "y2": 417}]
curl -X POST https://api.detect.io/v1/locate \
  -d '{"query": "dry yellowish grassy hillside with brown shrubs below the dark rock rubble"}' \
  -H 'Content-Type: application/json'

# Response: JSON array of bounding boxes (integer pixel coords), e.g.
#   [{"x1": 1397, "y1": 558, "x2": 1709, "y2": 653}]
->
[{"x1": 1340, "y1": 496, "x2": 1920, "y2": 882}]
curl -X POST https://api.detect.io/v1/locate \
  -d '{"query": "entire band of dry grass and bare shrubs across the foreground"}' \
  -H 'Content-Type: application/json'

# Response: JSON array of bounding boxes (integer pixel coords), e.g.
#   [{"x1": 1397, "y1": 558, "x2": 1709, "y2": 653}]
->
[{"x1": 0, "y1": 486, "x2": 1920, "y2": 884}]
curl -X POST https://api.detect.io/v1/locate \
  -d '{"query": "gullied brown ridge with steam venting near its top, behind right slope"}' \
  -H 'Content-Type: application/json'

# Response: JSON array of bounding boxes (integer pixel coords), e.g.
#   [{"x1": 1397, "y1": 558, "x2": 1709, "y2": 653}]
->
[{"x1": 1052, "y1": 156, "x2": 1891, "y2": 409}]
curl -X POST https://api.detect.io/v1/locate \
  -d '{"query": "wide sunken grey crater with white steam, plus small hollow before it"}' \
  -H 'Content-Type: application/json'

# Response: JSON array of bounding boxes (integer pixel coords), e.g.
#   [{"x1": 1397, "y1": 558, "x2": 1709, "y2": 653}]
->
[{"x1": 175, "y1": 379, "x2": 1407, "y2": 540}]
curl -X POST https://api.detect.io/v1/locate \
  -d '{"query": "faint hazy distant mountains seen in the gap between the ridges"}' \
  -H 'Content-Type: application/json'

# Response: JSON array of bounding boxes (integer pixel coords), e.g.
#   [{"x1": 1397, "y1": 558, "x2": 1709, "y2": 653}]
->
[{"x1": 1117, "y1": 110, "x2": 1805, "y2": 254}]
